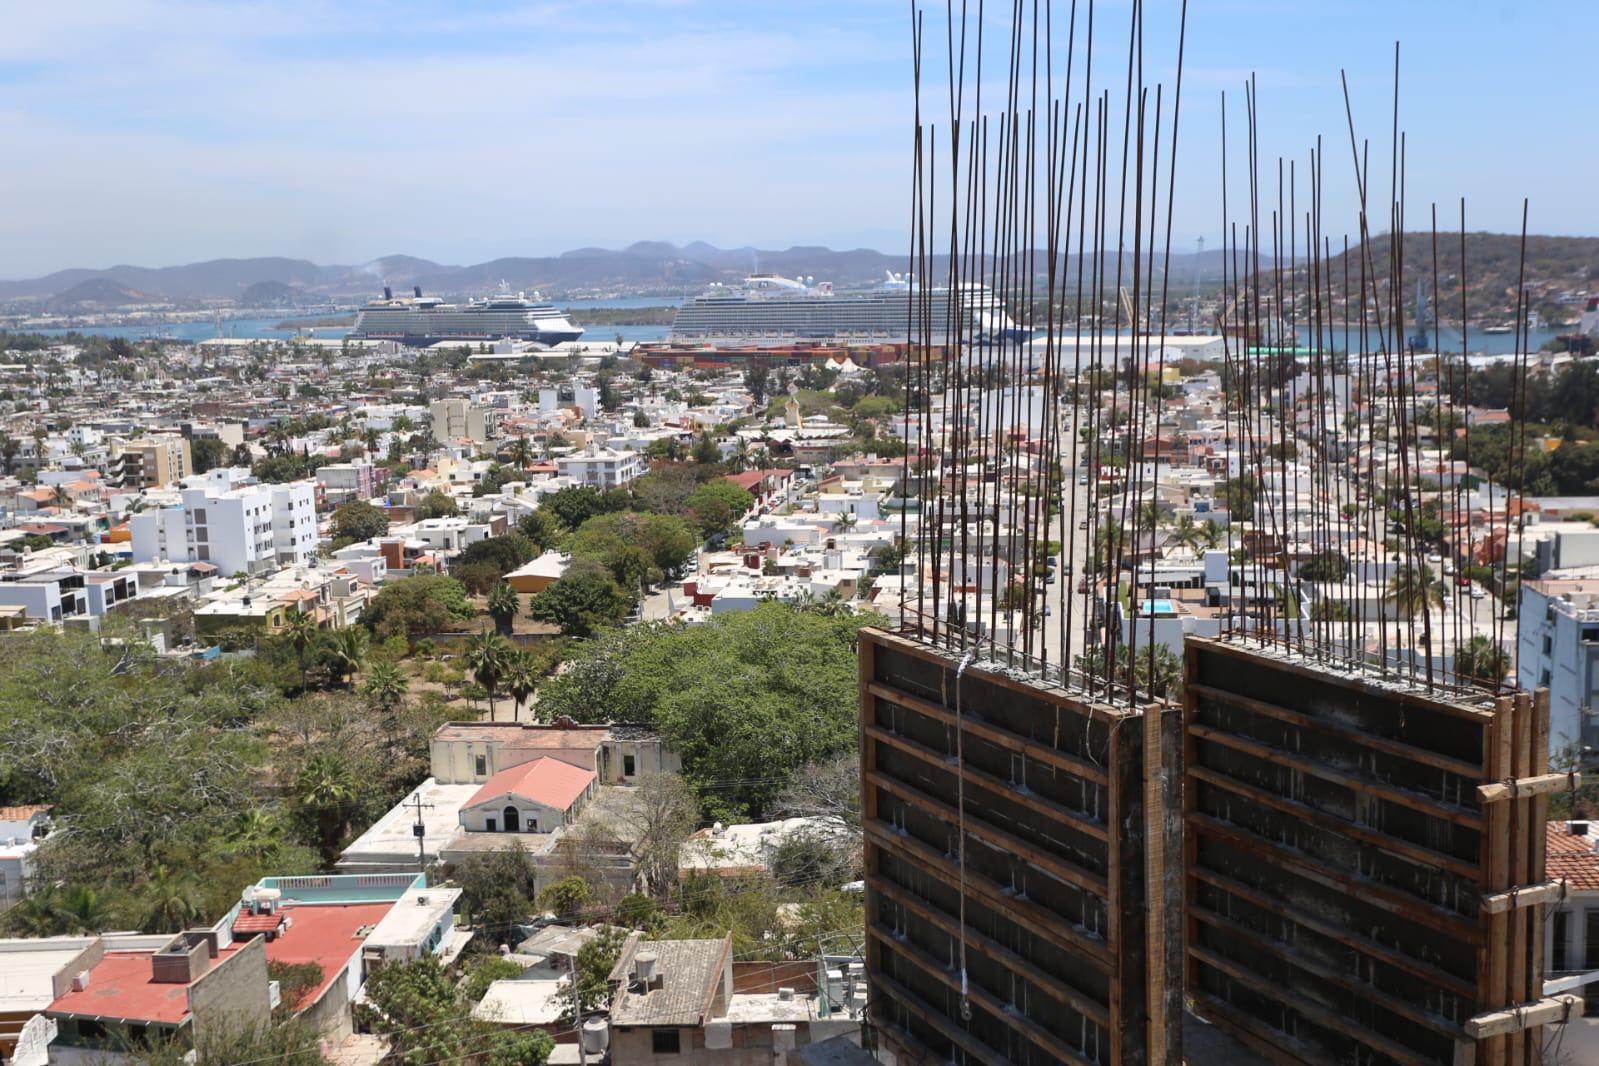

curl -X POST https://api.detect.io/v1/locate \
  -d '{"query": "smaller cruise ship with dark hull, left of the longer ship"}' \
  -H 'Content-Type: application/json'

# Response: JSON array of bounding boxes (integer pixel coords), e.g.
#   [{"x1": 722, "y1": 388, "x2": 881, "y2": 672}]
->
[{"x1": 352, "y1": 286, "x2": 584, "y2": 347}]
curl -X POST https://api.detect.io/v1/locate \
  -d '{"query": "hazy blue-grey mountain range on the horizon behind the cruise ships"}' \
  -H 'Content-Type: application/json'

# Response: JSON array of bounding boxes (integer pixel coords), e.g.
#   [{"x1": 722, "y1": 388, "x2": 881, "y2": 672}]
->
[{"x1": 0, "y1": 241, "x2": 1222, "y2": 310}]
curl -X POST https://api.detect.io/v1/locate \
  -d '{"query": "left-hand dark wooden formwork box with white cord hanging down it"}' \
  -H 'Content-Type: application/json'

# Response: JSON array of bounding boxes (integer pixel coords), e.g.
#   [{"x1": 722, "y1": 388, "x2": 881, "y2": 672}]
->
[{"x1": 860, "y1": 630, "x2": 1182, "y2": 1066}]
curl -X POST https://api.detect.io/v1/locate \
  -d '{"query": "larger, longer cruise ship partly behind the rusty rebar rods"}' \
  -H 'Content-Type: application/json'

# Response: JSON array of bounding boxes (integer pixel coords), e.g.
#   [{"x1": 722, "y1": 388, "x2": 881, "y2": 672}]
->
[{"x1": 668, "y1": 273, "x2": 1027, "y2": 344}]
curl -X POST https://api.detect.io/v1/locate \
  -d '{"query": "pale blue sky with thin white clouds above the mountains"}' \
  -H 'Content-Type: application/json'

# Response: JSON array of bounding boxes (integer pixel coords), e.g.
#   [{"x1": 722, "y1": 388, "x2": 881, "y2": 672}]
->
[{"x1": 0, "y1": 0, "x2": 1599, "y2": 278}]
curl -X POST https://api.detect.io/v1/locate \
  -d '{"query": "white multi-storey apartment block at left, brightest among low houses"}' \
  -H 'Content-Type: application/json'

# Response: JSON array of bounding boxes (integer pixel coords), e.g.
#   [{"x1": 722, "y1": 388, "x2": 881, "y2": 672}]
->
[{"x1": 128, "y1": 481, "x2": 317, "y2": 574}]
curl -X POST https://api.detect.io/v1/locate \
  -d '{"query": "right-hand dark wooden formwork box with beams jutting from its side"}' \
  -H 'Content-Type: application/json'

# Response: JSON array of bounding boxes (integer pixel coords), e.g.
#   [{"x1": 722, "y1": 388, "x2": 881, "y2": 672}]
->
[{"x1": 1183, "y1": 638, "x2": 1564, "y2": 1066}]
